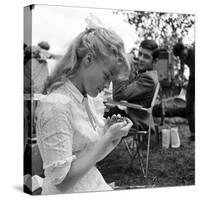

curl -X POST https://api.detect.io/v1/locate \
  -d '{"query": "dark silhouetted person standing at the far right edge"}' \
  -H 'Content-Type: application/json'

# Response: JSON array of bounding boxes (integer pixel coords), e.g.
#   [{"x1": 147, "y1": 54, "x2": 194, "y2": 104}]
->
[{"x1": 173, "y1": 42, "x2": 195, "y2": 141}]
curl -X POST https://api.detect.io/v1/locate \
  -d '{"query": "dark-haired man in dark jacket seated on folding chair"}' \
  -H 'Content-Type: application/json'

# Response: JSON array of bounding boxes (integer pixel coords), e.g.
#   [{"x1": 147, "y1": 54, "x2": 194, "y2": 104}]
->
[{"x1": 110, "y1": 40, "x2": 159, "y2": 130}]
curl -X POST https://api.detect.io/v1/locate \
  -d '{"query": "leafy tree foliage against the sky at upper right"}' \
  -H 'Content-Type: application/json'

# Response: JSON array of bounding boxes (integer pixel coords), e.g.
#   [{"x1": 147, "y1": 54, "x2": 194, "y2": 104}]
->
[{"x1": 113, "y1": 10, "x2": 195, "y2": 50}]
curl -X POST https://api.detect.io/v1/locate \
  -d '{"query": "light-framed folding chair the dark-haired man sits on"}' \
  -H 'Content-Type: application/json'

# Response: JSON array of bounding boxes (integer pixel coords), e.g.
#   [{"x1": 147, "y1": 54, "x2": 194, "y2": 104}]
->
[{"x1": 106, "y1": 83, "x2": 160, "y2": 178}]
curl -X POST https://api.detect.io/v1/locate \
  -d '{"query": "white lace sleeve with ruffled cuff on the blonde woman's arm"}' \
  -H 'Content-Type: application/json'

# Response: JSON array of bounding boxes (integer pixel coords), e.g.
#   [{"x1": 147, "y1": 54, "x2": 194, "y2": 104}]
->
[{"x1": 37, "y1": 105, "x2": 76, "y2": 184}]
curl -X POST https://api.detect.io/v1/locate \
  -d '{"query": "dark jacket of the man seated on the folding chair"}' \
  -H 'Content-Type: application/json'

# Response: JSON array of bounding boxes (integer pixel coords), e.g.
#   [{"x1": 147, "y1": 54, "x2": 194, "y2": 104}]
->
[{"x1": 113, "y1": 70, "x2": 158, "y2": 130}]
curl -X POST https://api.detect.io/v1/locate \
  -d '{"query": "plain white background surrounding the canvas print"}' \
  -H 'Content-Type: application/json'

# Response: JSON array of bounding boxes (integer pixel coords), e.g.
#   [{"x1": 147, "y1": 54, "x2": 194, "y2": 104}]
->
[{"x1": 0, "y1": 0, "x2": 200, "y2": 200}]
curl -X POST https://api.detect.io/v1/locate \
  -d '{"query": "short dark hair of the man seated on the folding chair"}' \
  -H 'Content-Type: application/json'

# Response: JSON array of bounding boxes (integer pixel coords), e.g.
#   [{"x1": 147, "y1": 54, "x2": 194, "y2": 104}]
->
[{"x1": 140, "y1": 40, "x2": 160, "y2": 60}]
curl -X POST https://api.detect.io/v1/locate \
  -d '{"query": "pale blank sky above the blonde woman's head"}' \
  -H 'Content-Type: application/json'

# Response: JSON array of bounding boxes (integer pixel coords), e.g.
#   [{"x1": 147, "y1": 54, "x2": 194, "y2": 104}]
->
[{"x1": 32, "y1": 5, "x2": 137, "y2": 53}]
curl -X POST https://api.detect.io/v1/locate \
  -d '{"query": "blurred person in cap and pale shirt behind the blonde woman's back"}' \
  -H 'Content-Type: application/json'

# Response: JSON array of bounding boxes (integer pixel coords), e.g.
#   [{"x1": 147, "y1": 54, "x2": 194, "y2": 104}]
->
[{"x1": 23, "y1": 41, "x2": 62, "y2": 149}]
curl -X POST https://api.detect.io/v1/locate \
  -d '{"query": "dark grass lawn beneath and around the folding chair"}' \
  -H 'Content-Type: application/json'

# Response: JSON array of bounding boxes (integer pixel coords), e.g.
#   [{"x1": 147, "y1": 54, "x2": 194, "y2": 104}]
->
[{"x1": 97, "y1": 118, "x2": 195, "y2": 188}]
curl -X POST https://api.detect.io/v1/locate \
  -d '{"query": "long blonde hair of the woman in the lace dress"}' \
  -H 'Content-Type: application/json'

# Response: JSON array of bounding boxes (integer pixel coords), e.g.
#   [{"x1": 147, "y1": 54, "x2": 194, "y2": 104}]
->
[{"x1": 44, "y1": 27, "x2": 124, "y2": 93}]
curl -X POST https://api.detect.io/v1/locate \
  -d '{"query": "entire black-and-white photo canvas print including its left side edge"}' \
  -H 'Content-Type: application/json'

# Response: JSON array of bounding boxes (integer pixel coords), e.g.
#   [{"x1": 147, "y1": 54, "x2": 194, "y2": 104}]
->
[{"x1": 23, "y1": 4, "x2": 196, "y2": 195}]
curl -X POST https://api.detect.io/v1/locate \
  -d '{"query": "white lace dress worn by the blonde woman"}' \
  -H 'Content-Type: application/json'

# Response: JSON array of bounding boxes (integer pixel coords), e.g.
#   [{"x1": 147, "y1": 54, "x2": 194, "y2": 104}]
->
[{"x1": 36, "y1": 81, "x2": 112, "y2": 194}]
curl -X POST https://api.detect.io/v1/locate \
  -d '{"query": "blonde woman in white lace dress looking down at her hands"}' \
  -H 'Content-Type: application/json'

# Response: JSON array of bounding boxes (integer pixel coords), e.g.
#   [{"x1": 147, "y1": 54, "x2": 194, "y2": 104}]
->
[{"x1": 36, "y1": 27, "x2": 132, "y2": 194}]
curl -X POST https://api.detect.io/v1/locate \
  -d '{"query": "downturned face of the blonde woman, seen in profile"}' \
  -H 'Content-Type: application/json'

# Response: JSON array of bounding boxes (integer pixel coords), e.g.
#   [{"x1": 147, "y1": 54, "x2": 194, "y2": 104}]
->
[{"x1": 82, "y1": 53, "x2": 129, "y2": 97}]
